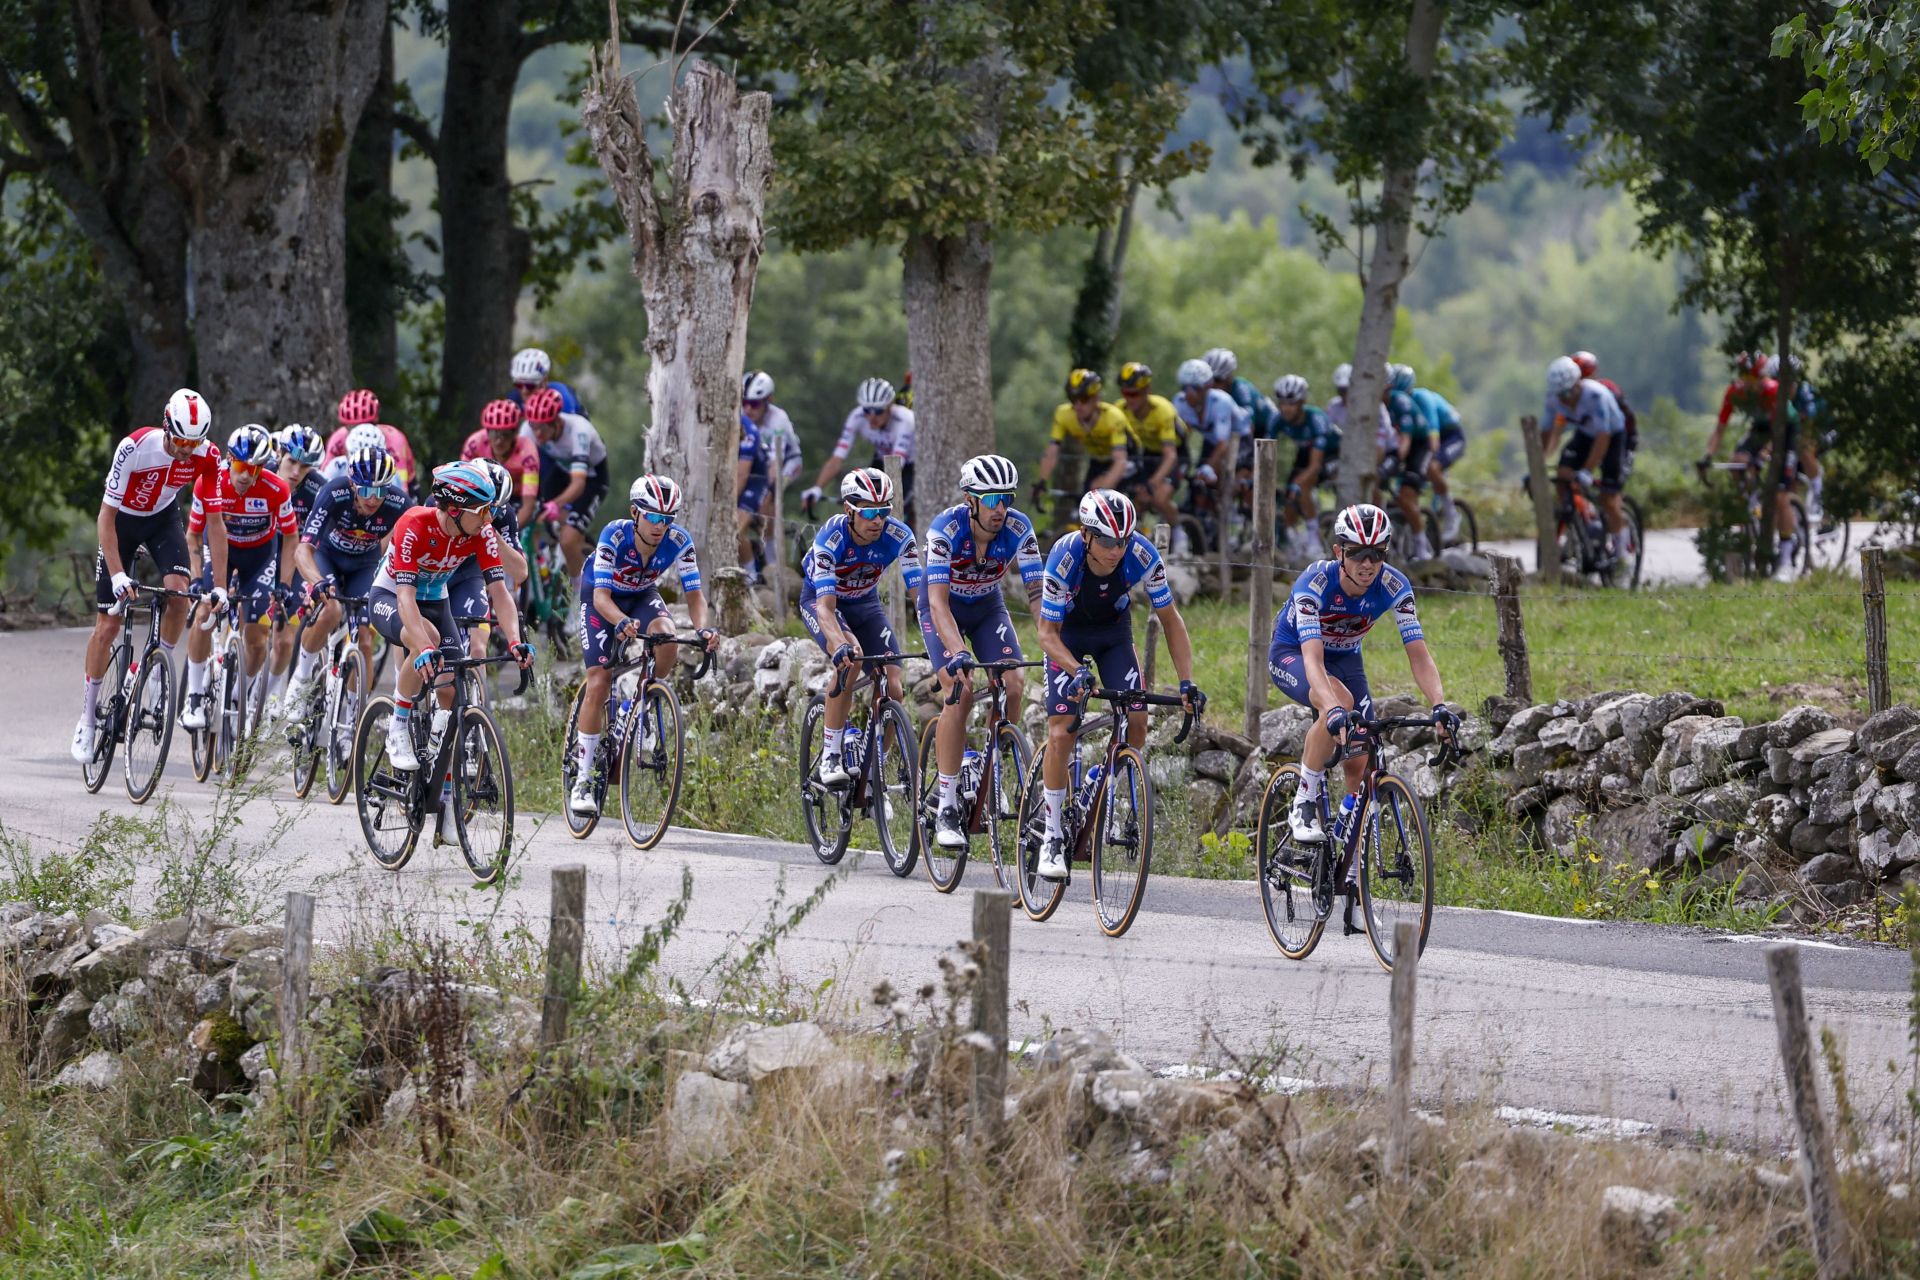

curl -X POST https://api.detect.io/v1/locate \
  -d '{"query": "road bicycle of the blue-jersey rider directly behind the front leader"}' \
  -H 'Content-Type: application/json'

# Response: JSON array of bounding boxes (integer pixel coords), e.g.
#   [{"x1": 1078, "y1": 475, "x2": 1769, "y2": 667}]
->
[{"x1": 1014, "y1": 689, "x2": 1194, "y2": 938}]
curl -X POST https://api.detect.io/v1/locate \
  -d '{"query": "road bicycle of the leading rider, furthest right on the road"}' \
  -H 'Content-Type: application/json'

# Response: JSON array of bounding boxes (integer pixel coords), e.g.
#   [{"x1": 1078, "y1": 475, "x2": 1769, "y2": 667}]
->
[{"x1": 1254, "y1": 716, "x2": 1459, "y2": 969}]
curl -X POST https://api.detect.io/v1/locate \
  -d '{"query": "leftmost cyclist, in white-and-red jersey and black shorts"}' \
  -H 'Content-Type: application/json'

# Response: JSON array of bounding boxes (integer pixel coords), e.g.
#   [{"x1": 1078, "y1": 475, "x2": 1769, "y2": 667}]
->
[{"x1": 69, "y1": 388, "x2": 227, "y2": 764}]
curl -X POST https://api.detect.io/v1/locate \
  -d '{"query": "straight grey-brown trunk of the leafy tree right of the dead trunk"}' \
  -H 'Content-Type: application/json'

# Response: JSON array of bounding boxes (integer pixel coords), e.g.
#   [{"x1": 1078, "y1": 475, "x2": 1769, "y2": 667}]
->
[{"x1": 900, "y1": 223, "x2": 995, "y2": 522}]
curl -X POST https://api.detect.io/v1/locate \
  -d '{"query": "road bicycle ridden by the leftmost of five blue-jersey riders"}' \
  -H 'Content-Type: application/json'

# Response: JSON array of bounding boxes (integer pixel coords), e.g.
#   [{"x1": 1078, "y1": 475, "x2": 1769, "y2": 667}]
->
[{"x1": 561, "y1": 633, "x2": 714, "y2": 848}]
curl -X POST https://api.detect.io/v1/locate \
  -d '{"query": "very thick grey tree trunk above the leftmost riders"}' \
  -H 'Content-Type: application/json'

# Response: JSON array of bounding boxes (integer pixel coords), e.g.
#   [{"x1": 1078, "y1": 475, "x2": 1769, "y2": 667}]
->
[{"x1": 190, "y1": 0, "x2": 386, "y2": 428}]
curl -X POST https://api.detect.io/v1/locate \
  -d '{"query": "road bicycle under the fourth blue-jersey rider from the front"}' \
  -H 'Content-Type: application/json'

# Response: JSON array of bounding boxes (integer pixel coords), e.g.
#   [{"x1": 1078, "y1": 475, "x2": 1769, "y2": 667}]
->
[{"x1": 801, "y1": 652, "x2": 925, "y2": 879}]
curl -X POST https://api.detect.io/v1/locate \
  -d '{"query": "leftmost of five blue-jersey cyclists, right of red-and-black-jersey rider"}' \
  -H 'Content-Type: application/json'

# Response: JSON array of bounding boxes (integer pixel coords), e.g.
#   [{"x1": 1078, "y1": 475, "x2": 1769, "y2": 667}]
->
[{"x1": 566, "y1": 476, "x2": 720, "y2": 816}]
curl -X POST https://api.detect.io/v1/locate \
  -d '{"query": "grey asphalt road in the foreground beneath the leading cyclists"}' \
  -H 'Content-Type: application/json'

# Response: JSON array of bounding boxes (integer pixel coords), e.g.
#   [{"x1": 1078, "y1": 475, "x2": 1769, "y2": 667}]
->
[{"x1": 0, "y1": 629, "x2": 1908, "y2": 1146}]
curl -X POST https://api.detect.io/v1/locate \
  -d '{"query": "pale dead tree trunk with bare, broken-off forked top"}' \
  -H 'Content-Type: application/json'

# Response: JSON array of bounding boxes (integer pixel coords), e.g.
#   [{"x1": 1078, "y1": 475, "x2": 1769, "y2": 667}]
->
[{"x1": 580, "y1": 50, "x2": 774, "y2": 566}]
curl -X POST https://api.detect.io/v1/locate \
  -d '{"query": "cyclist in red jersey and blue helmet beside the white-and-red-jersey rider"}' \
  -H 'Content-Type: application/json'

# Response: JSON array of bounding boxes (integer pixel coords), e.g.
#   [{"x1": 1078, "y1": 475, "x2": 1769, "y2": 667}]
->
[{"x1": 180, "y1": 422, "x2": 300, "y2": 729}]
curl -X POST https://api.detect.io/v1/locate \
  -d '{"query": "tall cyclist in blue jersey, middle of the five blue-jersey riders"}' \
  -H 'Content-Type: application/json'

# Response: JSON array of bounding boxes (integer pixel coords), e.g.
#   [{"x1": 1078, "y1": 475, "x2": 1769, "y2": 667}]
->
[{"x1": 918, "y1": 453, "x2": 1043, "y2": 848}]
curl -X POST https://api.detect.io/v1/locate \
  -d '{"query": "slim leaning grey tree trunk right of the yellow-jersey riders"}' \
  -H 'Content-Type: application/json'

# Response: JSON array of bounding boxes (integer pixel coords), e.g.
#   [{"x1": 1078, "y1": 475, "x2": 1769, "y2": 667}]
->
[{"x1": 1338, "y1": 0, "x2": 1440, "y2": 507}]
